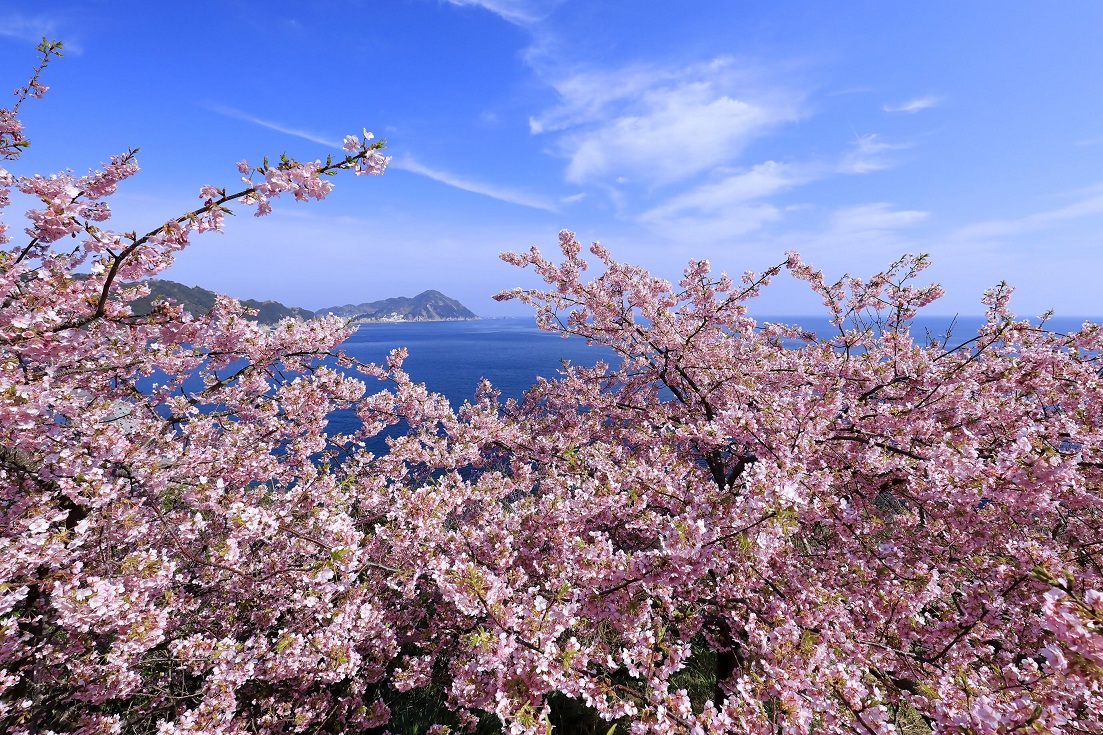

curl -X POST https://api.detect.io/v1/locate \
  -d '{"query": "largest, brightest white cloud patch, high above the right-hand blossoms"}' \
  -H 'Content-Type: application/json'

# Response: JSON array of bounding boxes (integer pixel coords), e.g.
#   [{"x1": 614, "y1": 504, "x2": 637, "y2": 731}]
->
[{"x1": 529, "y1": 58, "x2": 800, "y2": 183}]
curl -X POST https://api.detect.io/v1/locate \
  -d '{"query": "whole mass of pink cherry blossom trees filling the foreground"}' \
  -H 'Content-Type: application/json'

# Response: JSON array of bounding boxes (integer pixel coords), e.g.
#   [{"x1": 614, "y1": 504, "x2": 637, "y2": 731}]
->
[{"x1": 0, "y1": 41, "x2": 1103, "y2": 735}]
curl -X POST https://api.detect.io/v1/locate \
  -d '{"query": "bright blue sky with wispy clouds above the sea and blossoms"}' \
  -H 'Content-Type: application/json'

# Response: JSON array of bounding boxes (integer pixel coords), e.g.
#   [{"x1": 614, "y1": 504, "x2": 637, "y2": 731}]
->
[{"x1": 0, "y1": 0, "x2": 1103, "y2": 316}]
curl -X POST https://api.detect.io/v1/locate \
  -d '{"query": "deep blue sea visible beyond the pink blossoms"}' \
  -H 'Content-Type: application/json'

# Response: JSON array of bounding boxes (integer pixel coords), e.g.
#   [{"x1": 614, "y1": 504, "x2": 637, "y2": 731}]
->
[{"x1": 329, "y1": 317, "x2": 1099, "y2": 441}]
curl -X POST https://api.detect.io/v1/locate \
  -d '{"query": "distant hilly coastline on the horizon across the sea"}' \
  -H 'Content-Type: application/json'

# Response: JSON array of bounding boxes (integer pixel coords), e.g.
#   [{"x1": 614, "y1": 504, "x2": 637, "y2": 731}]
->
[{"x1": 130, "y1": 278, "x2": 479, "y2": 324}]
